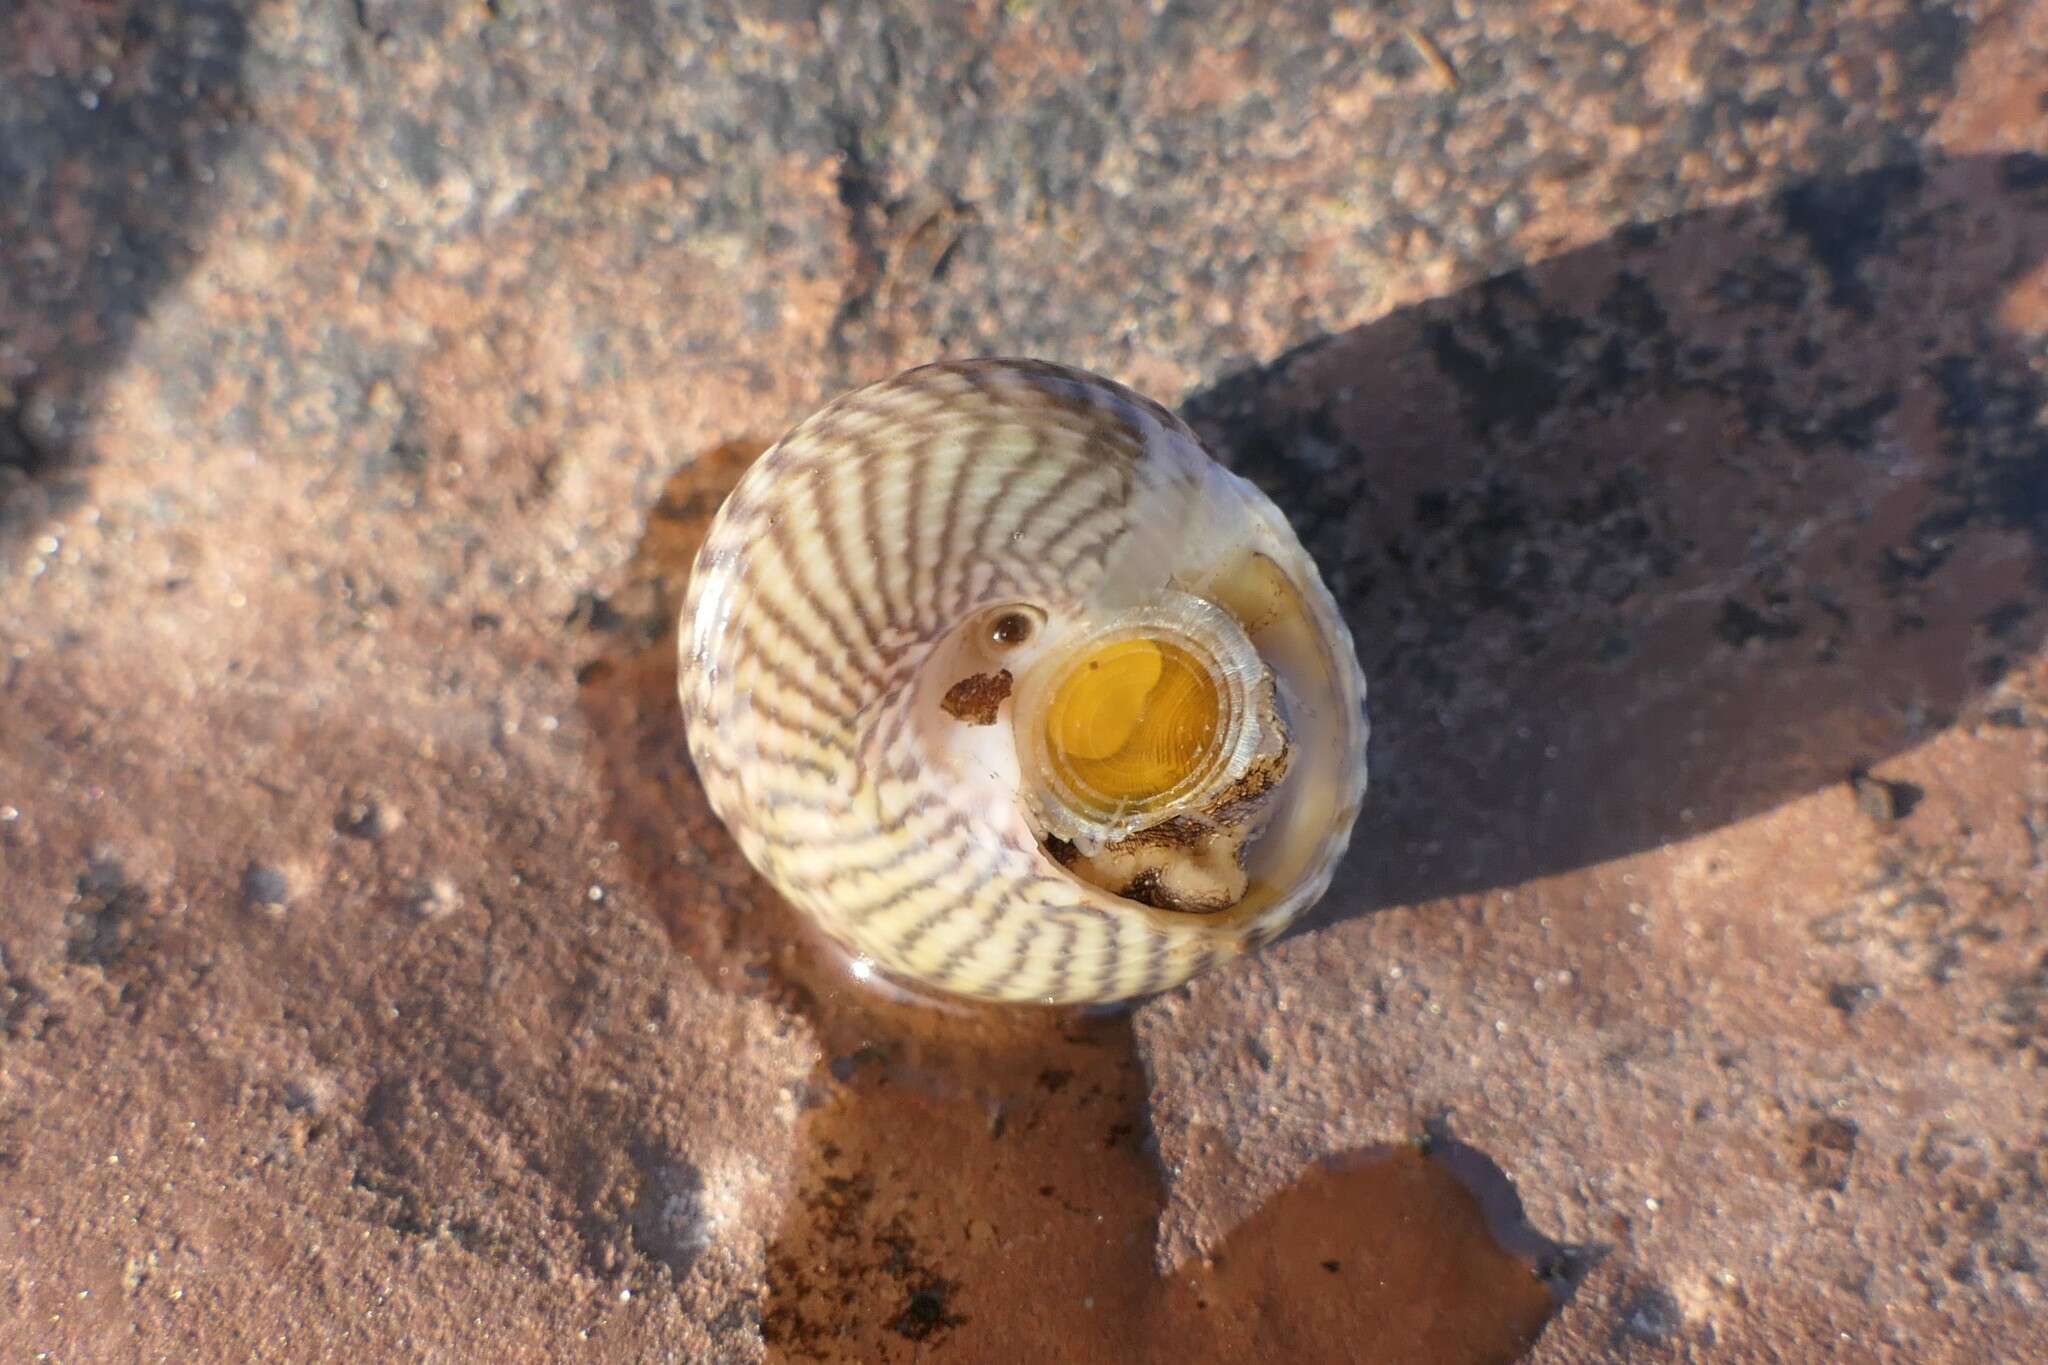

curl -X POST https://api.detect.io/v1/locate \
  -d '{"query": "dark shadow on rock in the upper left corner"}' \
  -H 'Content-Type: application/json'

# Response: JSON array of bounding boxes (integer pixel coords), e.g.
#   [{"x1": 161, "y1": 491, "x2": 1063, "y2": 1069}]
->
[{"x1": 0, "y1": 0, "x2": 254, "y2": 565}]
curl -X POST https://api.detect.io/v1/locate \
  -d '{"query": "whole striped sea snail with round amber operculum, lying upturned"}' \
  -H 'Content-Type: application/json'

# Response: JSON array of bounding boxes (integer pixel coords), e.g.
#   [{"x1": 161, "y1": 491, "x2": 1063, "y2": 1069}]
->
[{"x1": 680, "y1": 360, "x2": 1366, "y2": 1003}]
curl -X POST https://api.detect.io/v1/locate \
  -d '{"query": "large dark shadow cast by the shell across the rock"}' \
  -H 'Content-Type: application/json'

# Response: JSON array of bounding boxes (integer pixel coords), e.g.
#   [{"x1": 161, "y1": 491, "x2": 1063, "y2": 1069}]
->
[{"x1": 1184, "y1": 153, "x2": 2048, "y2": 923}]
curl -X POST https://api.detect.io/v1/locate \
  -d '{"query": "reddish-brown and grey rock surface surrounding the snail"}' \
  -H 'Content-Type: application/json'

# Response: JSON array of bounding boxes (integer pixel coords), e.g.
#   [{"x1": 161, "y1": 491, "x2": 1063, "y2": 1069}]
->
[{"x1": 0, "y1": 0, "x2": 2048, "y2": 1365}]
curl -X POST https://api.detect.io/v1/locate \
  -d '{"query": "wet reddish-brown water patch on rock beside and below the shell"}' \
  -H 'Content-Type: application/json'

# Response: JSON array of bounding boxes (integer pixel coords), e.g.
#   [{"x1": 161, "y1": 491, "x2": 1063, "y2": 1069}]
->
[{"x1": 585, "y1": 442, "x2": 1579, "y2": 1363}]
